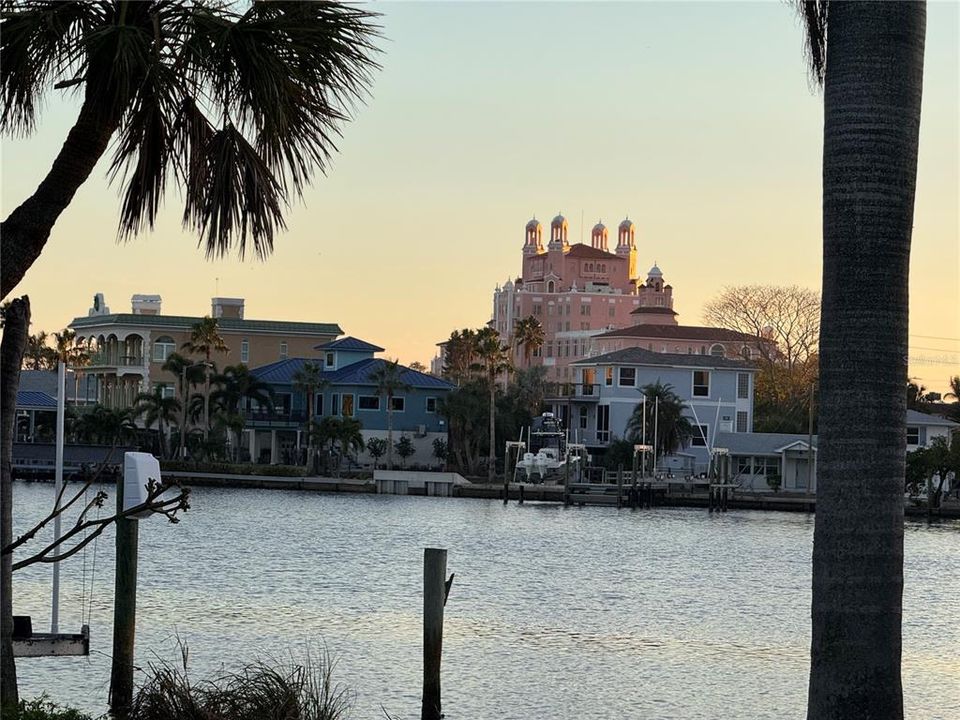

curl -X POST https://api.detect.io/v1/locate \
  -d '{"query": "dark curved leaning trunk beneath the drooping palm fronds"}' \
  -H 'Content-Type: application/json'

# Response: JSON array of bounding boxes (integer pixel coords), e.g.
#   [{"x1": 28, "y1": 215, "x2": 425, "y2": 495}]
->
[{"x1": 0, "y1": 94, "x2": 121, "y2": 297}]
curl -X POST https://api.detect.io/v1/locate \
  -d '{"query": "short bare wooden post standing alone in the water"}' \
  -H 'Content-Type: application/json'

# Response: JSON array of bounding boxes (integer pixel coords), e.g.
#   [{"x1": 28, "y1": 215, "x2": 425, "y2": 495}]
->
[{"x1": 420, "y1": 548, "x2": 447, "y2": 720}]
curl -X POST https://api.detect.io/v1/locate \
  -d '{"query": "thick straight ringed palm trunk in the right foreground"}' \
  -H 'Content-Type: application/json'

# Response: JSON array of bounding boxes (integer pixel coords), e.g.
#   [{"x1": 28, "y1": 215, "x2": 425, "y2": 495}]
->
[{"x1": 807, "y1": 2, "x2": 926, "y2": 720}]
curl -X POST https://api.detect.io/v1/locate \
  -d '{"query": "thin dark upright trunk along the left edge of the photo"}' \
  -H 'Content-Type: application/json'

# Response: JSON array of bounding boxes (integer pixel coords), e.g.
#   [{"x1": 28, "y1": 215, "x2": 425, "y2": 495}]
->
[{"x1": 0, "y1": 296, "x2": 30, "y2": 705}]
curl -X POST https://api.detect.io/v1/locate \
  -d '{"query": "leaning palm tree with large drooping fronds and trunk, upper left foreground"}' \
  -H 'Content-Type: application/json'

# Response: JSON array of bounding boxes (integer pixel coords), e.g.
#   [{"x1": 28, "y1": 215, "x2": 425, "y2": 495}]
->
[{"x1": 0, "y1": 0, "x2": 377, "y2": 297}]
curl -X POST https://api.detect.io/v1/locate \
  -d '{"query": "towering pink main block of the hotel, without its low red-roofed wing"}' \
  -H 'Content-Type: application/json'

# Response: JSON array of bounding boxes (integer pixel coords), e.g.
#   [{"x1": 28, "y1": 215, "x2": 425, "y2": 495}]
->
[{"x1": 492, "y1": 215, "x2": 677, "y2": 381}]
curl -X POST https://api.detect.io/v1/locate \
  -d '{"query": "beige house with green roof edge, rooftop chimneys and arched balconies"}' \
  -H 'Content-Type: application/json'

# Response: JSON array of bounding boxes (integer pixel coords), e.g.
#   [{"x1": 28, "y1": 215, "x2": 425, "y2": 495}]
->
[{"x1": 70, "y1": 293, "x2": 343, "y2": 408}]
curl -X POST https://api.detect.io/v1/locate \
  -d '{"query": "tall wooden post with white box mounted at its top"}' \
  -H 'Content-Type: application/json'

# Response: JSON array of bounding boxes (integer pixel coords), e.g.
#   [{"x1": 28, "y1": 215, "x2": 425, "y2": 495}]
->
[{"x1": 110, "y1": 464, "x2": 139, "y2": 720}]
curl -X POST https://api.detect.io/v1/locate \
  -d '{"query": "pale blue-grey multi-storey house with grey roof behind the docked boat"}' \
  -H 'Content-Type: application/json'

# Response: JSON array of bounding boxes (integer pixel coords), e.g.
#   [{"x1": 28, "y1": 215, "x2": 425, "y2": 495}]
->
[{"x1": 564, "y1": 348, "x2": 756, "y2": 472}]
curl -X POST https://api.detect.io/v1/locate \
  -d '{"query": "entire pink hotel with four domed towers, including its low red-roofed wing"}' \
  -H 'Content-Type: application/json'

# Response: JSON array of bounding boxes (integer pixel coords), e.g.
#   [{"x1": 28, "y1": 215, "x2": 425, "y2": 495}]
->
[{"x1": 491, "y1": 215, "x2": 757, "y2": 383}]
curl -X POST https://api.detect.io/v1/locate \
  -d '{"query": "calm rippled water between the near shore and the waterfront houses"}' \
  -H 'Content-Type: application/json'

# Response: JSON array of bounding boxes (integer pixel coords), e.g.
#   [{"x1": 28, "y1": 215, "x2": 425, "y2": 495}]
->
[{"x1": 14, "y1": 483, "x2": 960, "y2": 720}]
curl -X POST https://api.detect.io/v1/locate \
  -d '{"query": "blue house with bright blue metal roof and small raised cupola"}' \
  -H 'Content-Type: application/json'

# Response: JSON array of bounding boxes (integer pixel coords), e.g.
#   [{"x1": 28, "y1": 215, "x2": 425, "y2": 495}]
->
[{"x1": 243, "y1": 337, "x2": 454, "y2": 465}]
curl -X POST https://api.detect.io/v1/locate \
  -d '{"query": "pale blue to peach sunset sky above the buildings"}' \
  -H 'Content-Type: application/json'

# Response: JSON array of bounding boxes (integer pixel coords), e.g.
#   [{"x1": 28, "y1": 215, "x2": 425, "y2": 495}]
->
[{"x1": 0, "y1": 2, "x2": 960, "y2": 390}]
